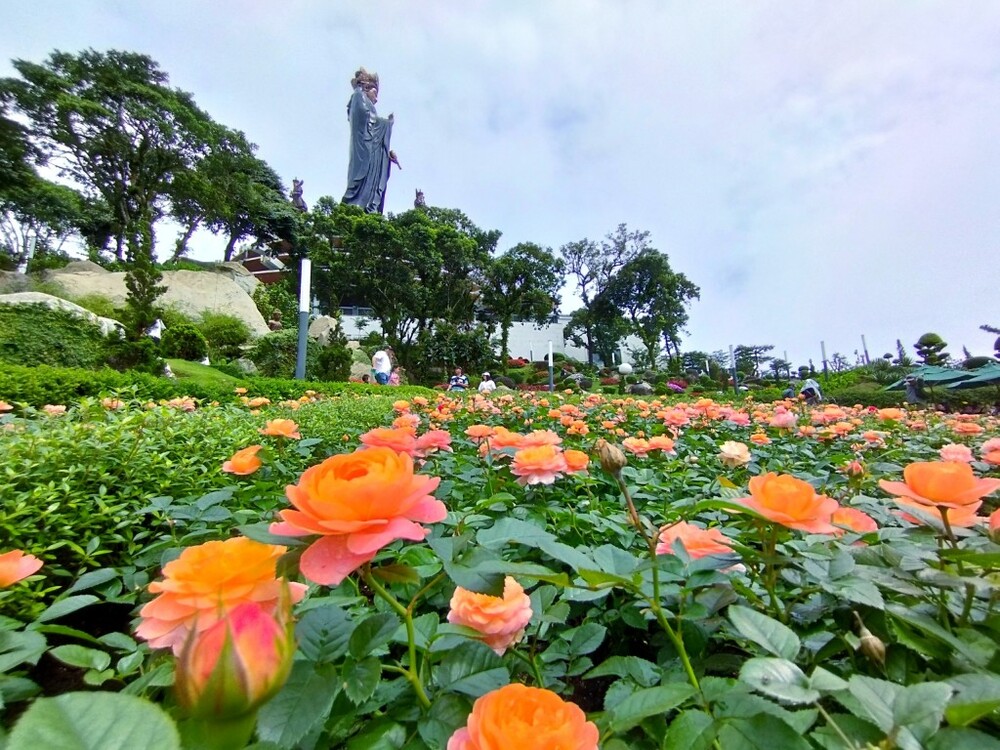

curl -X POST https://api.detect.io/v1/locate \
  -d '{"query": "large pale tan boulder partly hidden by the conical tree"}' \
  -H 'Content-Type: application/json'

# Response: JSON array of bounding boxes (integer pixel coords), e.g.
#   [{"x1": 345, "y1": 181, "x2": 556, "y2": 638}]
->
[{"x1": 48, "y1": 261, "x2": 268, "y2": 336}]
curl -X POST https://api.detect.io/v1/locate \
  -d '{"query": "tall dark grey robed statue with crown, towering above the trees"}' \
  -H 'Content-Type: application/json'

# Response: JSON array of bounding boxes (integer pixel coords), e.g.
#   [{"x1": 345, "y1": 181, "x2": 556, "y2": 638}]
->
[{"x1": 342, "y1": 68, "x2": 399, "y2": 214}]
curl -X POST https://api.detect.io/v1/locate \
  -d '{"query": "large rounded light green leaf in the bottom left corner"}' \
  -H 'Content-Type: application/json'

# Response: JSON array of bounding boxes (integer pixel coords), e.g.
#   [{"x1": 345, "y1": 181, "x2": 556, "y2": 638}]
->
[{"x1": 7, "y1": 693, "x2": 180, "y2": 750}]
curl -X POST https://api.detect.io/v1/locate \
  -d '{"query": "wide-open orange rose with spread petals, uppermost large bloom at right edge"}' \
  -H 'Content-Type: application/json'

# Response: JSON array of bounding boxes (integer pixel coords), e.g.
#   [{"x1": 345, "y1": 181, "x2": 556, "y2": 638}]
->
[{"x1": 879, "y1": 461, "x2": 1000, "y2": 520}]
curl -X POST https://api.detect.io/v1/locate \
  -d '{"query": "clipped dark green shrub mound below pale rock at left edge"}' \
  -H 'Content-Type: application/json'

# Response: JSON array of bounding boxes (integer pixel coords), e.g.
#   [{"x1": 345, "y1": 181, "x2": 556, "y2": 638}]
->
[{"x1": 0, "y1": 305, "x2": 105, "y2": 368}]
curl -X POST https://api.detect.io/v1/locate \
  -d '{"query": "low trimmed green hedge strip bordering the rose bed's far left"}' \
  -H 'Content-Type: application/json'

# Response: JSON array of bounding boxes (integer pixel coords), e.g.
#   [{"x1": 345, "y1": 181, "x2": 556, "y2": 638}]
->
[{"x1": 0, "y1": 363, "x2": 434, "y2": 408}]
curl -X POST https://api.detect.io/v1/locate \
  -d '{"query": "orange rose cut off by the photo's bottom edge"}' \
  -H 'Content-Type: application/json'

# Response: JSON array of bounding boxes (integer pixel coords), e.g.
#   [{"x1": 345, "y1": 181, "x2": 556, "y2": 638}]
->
[{"x1": 447, "y1": 684, "x2": 599, "y2": 750}]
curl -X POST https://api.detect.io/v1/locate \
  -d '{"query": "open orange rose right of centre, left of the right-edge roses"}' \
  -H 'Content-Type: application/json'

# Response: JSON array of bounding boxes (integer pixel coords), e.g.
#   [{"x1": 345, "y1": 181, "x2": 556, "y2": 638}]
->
[{"x1": 737, "y1": 472, "x2": 839, "y2": 534}]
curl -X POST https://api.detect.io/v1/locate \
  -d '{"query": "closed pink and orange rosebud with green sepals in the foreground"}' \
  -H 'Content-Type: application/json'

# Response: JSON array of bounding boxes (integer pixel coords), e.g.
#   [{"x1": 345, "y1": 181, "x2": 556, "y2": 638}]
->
[{"x1": 174, "y1": 602, "x2": 295, "y2": 719}]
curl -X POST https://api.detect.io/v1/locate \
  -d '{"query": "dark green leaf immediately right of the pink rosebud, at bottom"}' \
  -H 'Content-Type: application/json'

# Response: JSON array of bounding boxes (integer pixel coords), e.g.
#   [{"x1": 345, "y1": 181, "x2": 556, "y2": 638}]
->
[{"x1": 257, "y1": 661, "x2": 338, "y2": 747}]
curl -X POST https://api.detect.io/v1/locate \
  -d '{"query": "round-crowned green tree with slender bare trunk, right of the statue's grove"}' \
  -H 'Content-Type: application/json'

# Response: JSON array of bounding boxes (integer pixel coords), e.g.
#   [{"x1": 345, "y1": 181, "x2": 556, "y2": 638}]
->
[{"x1": 481, "y1": 242, "x2": 565, "y2": 373}]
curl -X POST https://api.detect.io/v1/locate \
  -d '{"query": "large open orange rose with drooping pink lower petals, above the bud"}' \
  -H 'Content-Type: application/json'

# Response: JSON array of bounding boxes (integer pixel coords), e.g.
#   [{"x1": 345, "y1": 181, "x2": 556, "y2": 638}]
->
[{"x1": 271, "y1": 447, "x2": 448, "y2": 586}]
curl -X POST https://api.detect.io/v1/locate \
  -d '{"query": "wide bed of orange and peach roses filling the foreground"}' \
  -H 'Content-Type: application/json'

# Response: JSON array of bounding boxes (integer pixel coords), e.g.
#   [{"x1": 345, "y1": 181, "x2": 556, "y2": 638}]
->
[{"x1": 0, "y1": 393, "x2": 1000, "y2": 750}]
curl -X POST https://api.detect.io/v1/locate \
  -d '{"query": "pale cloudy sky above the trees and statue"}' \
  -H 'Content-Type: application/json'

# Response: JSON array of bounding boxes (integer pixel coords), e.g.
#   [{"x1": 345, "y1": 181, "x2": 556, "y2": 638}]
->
[{"x1": 0, "y1": 0, "x2": 1000, "y2": 365}]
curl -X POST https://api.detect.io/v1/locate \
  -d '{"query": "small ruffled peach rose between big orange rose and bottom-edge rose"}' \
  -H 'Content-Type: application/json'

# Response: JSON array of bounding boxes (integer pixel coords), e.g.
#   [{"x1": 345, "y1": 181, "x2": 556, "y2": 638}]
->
[{"x1": 448, "y1": 576, "x2": 532, "y2": 656}]
